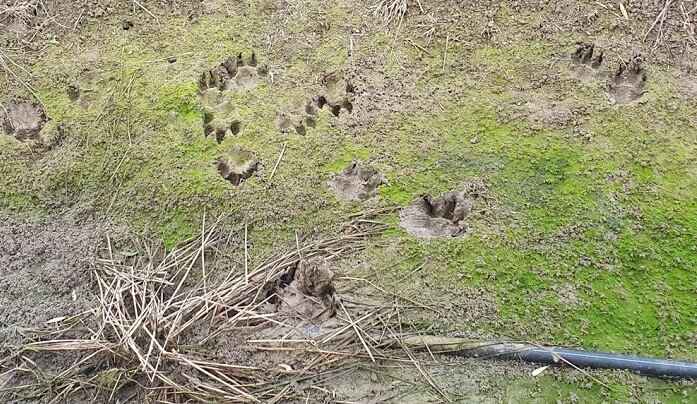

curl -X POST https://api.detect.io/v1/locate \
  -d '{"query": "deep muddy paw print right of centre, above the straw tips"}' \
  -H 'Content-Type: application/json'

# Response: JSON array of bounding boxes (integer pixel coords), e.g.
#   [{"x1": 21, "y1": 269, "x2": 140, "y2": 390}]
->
[{"x1": 400, "y1": 183, "x2": 486, "y2": 238}]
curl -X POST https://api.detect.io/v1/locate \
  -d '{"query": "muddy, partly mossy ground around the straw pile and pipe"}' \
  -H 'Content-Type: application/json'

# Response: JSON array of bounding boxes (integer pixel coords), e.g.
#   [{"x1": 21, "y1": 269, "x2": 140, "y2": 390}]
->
[{"x1": 0, "y1": 0, "x2": 697, "y2": 402}]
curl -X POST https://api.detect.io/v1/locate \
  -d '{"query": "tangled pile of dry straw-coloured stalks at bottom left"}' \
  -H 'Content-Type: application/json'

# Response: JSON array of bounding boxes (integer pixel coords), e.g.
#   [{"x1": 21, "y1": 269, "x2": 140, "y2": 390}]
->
[{"x1": 0, "y1": 210, "x2": 452, "y2": 402}]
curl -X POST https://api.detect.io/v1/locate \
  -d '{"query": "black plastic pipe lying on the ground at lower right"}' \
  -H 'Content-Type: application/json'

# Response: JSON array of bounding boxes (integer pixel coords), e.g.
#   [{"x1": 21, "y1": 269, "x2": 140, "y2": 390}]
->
[{"x1": 452, "y1": 343, "x2": 697, "y2": 379}]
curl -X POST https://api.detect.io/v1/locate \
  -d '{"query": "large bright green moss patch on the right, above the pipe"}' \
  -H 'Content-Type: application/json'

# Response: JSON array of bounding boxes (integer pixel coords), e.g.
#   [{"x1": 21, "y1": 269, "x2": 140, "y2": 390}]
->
[{"x1": 346, "y1": 82, "x2": 697, "y2": 357}]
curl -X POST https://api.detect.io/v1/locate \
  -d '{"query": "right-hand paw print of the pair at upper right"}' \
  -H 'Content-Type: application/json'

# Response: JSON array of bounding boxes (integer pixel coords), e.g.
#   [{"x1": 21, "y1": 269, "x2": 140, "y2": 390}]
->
[{"x1": 605, "y1": 54, "x2": 646, "y2": 105}]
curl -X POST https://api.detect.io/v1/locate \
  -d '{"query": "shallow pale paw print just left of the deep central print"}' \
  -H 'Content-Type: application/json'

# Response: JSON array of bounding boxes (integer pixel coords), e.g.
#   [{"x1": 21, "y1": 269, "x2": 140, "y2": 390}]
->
[{"x1": 329, "y1": 162, "x2": 387, "y2": 201}]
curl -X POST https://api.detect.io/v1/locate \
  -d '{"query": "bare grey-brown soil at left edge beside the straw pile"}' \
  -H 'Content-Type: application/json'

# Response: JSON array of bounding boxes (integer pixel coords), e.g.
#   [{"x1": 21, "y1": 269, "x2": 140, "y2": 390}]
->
[{"x1": 0, "y1": 210, "x2": 105, "y2": 342}]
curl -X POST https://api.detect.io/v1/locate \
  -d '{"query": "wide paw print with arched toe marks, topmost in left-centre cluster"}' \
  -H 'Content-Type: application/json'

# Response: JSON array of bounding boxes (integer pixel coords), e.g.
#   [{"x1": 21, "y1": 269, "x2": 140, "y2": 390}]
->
[{"x1": 198, "y1": 52, "x2": 269, "y2": 91}]
